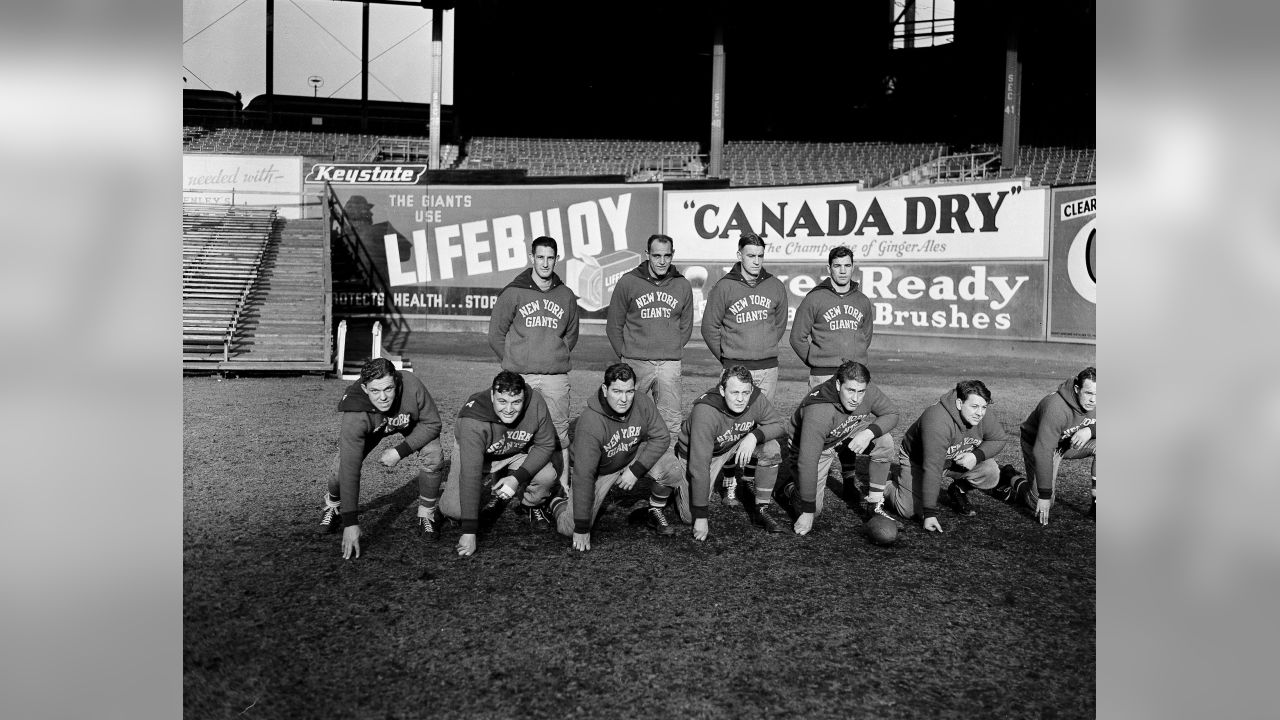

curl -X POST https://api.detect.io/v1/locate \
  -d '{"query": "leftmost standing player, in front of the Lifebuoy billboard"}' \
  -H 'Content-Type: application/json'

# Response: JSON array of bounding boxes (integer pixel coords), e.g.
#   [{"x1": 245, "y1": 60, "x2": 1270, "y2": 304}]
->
[{"x1": 489, "y1": 236, "x2": 577, "y2": 483}]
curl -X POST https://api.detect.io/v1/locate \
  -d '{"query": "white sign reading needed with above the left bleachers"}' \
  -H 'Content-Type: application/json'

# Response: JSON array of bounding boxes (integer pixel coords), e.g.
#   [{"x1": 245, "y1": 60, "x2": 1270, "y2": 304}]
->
[{"x1": 182, "y1": 152, "x2": 304, "y2": 218}]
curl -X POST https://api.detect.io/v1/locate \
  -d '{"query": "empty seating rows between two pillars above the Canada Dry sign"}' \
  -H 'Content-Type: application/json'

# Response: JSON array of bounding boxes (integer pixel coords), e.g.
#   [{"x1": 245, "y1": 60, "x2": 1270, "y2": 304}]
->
[{"x1": 723, "y1": 140, "x2": 946, "y2": 187}]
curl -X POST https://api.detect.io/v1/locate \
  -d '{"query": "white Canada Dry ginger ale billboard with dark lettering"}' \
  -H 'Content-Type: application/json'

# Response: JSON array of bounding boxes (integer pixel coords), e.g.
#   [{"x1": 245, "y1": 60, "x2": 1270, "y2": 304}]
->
[{"x1": 664, "y1": 181, "x2": 1048, "y2": 266}]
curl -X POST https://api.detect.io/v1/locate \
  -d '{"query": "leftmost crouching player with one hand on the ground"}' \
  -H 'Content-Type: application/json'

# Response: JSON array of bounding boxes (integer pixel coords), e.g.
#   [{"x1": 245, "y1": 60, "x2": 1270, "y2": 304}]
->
[{"x1": 320, "y1": 357, "x2": 442, "y2": 560}]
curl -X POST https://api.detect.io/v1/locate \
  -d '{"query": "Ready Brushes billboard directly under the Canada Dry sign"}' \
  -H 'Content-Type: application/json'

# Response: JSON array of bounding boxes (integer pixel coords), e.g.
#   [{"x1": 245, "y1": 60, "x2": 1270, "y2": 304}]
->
[{"x1": 681, "y1": 261, "x2": 1046, "y2": 340}]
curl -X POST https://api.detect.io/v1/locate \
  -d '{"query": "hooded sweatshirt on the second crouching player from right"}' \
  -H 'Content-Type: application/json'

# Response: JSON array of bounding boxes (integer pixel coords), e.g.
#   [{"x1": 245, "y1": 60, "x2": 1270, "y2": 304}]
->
[{"x1": 900, "y1": 389, "x2": 1007, "y2": 518}]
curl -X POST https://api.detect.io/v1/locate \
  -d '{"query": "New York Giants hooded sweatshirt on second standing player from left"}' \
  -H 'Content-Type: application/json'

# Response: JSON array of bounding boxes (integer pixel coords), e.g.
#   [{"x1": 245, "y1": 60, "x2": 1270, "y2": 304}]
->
[{"x1": 604, "y1": 260, "x2": 694, "y2": 360}]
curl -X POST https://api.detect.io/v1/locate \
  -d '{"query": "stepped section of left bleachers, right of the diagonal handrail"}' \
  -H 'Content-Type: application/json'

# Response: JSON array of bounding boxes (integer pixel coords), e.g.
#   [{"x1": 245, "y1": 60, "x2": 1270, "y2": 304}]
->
[{"x1": 183, "y1": 219, "x2": 334, "y2": 373}]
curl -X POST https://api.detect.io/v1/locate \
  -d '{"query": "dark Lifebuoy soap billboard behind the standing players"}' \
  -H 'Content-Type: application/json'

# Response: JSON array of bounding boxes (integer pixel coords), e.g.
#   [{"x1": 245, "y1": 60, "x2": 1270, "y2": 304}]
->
[{"x1": 322, "y1": 183, "x2": 662, "y2": 320}]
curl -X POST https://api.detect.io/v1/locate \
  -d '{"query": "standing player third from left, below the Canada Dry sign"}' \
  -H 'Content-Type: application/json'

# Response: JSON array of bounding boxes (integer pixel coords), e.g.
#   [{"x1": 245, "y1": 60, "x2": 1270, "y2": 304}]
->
[{"x1": 701, "y1": 233, "x2": 790, "y2": 502}]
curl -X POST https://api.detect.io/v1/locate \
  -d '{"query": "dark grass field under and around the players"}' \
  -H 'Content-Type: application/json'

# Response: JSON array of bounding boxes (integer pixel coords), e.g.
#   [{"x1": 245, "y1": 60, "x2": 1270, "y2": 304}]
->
[{"x1": 183, "y1": 333, "x2": 1096, "y2": 720}]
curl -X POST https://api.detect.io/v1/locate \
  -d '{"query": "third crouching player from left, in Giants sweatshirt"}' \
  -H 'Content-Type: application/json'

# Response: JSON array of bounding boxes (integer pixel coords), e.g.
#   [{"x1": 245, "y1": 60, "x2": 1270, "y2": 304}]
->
[{"x1": 550, "y1": 363, "x2": 676, "y2": 551}]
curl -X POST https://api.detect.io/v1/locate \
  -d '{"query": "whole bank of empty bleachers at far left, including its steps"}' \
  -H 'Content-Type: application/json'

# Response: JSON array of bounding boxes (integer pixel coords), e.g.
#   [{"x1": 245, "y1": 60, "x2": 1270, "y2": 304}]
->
[{"x1": 182, "y1": 204, "x2": 334, "y2": 373}]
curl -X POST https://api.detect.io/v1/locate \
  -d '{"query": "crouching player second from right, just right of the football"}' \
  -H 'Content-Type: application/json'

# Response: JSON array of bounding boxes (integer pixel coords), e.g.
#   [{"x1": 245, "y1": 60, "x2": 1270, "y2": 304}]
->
[{"x1": 884, "y1": 380, "x2": 1006, "y2": 533}]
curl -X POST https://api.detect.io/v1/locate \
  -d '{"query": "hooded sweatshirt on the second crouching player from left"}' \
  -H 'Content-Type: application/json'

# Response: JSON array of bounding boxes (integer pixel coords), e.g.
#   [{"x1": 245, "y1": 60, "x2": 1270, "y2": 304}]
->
[{"x1": 453, "y1": 388, "x2": 559, "y2": 534}]
